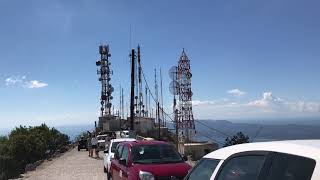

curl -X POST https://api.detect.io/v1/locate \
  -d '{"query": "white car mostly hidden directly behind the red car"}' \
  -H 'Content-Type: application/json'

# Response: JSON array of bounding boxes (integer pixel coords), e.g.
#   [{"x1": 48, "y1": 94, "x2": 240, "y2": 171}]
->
[{"x1": 103, "y1": 138, "x2": 136, "y2": 173}]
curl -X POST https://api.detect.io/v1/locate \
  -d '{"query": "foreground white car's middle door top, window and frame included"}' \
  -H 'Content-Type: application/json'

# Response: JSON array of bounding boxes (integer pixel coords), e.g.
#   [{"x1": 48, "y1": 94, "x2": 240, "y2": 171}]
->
[{"x1": 214, "y1": 152, "x2": 270, "y2": 180}]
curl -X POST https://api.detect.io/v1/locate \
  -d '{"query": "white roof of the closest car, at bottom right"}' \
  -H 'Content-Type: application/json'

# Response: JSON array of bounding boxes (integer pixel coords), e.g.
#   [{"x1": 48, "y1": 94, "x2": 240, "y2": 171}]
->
[{"x1": 204, "y1": 140, "x2": 320, "y2": 160}]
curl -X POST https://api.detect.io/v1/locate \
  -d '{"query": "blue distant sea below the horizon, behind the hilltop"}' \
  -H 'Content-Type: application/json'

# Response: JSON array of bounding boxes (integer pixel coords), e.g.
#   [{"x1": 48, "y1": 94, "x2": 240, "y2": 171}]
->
[{"x1": 0, "y1": 119, "x2": 320, "y2": 146}]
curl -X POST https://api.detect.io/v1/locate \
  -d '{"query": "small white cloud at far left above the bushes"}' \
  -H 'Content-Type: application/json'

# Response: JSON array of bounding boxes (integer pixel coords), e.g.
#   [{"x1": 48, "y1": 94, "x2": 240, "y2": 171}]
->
[{"x1": 5, "y1": 76, "x2": 48, "y2": 89}]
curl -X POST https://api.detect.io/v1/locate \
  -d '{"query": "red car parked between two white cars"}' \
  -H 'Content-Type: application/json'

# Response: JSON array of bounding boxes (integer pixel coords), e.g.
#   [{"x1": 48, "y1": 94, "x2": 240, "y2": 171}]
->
[{"x1": 108, "y1": 141, "x2": 191, "y2": 180}]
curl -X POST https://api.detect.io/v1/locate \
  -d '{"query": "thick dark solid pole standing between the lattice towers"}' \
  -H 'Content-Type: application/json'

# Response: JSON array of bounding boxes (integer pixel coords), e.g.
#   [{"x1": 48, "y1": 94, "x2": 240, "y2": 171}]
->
[{"x1": 130, "y1": 49, "x2": 135, "y2": 130}]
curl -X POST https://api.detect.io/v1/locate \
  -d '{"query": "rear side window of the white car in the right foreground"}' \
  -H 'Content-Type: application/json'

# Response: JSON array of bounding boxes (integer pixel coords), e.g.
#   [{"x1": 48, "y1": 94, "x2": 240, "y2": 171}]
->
[{"x1": 266, "y1": 153, "x2": 316, "y2": 180}]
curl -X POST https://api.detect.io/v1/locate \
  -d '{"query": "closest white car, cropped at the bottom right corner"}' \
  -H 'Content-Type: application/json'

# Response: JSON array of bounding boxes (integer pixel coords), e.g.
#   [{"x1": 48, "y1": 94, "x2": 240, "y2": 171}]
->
[{"x1": 185, "y1": 140, "x2": 320, "y2": 180}]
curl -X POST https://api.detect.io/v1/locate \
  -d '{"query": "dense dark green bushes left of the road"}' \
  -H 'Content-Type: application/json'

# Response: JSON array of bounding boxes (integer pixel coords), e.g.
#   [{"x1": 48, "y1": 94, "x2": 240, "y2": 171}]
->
[{"x1": 0, "y1": 124, "x2": 70, "y2": 179}]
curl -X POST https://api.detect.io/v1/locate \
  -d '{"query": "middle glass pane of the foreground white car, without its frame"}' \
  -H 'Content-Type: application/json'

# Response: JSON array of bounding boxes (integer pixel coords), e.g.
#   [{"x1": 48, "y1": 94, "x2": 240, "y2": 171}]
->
[{"x1": 218, "y1": 155, "x2": 265, "y2": 180}]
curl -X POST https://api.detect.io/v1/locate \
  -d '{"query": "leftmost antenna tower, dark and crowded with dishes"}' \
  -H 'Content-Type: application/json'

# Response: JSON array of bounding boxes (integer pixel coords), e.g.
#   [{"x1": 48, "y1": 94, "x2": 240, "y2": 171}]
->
[{"x1": 96, "y1": 45, "x2": 114, "y2": 116}]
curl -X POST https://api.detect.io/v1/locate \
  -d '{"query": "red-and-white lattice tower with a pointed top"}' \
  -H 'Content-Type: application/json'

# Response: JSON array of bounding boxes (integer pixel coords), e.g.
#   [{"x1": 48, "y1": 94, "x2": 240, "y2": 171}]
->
[{"x1": 177, "y1": 49, "x2": 195, "y2": 142}]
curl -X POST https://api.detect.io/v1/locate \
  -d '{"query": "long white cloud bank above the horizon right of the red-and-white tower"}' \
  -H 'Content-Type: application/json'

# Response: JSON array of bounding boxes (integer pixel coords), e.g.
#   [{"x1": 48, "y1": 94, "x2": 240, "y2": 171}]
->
[{"x1": 193, "y1": 92, "x2": 320, "y2": 119}]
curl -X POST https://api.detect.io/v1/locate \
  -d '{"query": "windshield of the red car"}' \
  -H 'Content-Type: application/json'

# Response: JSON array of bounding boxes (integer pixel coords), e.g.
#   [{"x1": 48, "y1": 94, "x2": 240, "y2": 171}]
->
[{"x1": 132, "y1": 144, "x2": 183, "y2": 164}]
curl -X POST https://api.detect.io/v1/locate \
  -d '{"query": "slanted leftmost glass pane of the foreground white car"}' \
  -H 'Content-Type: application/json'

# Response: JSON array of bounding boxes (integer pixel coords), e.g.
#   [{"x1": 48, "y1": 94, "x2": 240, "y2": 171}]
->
[{"x1": 186, "y1": 158, "x2": 220, "y2": 180}]
